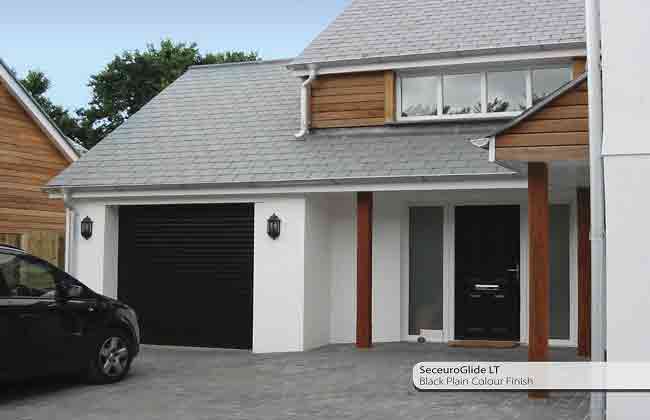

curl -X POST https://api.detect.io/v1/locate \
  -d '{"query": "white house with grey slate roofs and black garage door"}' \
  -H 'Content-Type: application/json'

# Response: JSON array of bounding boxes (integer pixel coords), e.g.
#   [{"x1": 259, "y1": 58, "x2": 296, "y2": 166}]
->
[{"x1": 47, "y1": 0, "x2": 590, "y2": 360}]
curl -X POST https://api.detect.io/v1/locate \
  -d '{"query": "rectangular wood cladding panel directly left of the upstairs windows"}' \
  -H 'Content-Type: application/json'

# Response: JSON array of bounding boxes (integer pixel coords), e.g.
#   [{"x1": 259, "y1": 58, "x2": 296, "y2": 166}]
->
[{"x1": 310, "y1": 71, "x2": 395, "y2": 128}]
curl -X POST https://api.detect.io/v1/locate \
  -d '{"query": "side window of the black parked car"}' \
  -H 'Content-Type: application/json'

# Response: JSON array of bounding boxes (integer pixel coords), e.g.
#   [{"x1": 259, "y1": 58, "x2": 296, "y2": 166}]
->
[{"x1": 0, "y1": 254, "x2": 56, "y2": 298}]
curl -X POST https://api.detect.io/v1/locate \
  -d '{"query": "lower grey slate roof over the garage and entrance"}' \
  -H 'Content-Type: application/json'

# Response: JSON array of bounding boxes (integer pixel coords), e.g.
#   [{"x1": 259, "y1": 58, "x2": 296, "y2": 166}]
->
[{"x1": 49, "y1": 61, "x2": 510, "y2": 188}]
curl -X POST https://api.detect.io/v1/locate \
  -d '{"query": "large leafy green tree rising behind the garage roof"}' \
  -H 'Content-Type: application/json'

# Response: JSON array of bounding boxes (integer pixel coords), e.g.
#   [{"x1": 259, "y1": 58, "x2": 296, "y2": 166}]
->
[{"x1": 78, "y1": 39, "x2": 259, "y2": 147}]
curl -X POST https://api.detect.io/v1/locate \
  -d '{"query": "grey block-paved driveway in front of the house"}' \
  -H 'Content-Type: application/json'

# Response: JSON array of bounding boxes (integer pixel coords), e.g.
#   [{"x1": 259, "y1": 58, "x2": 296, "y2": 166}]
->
[{"x1": 0, "y1": 343, "x2": 589, "y2": 420}]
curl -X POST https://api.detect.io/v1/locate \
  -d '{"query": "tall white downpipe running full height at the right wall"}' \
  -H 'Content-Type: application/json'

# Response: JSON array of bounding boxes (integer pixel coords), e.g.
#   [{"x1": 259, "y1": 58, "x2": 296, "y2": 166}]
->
[{"x1": 585, "y1": 0, "x2": 606, "y2": 419}]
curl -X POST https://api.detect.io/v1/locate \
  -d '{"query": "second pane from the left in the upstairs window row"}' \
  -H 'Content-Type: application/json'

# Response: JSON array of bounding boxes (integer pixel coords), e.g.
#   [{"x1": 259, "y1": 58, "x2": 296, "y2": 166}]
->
[{"x1": 443, "y1": 74, "x2": 481, "y2": 115}]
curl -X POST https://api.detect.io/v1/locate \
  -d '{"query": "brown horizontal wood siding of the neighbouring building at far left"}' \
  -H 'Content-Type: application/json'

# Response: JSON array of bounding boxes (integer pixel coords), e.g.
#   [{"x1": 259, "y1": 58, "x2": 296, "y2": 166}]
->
[{"x1": 0, "y1": 83, "x2": 69, "y2": 234}]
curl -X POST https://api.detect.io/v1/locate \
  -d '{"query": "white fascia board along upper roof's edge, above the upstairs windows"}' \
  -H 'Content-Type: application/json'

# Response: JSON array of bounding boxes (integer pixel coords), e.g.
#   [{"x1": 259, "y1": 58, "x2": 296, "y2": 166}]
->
[{"x1": 289, "y1": 47, "x2": 587, "y2": 77}]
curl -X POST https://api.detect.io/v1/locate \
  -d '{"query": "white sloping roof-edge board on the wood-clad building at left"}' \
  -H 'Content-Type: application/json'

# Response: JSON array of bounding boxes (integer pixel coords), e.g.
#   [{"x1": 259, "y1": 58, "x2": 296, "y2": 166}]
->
[{"x1": 0, "y1": 60, "x2": 79, "y2": 162}]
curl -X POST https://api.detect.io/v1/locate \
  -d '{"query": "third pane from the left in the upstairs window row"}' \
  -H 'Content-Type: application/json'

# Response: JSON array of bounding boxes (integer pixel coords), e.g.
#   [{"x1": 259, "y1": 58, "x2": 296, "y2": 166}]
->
[{"x1": 487, "y1": 71, "x2": 526, "y2": 112}]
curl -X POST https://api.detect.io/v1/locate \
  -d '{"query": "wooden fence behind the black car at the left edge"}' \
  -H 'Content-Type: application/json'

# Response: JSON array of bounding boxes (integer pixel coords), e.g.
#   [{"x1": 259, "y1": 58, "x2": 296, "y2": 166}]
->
[{"x1": 0, "y1": 231, "x2": 65, "y2": 269}]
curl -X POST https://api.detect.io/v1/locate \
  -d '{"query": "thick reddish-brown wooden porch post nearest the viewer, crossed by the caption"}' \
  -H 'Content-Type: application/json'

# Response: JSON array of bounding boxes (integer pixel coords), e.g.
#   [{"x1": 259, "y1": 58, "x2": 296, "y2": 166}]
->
[{"x1": 528, "y1": 162, "x2": 550, "y2": 398}]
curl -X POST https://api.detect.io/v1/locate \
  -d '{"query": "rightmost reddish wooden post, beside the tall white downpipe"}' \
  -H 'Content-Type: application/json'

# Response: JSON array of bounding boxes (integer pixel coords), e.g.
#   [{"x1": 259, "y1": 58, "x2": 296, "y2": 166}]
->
[{"x1": 577, "y1": 188, "x2": 591, "y2": 357}]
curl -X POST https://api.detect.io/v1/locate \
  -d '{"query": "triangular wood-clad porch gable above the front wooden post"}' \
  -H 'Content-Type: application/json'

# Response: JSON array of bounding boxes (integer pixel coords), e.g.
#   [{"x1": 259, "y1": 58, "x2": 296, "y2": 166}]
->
[{"x1": 495, "y1": 77, "x2": 589, "y2": 162}]
